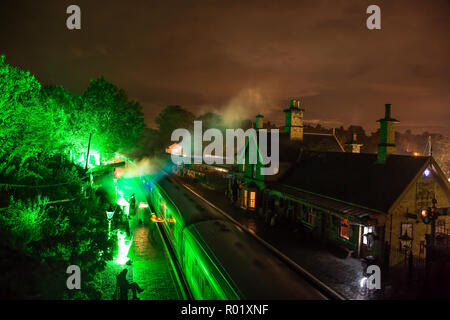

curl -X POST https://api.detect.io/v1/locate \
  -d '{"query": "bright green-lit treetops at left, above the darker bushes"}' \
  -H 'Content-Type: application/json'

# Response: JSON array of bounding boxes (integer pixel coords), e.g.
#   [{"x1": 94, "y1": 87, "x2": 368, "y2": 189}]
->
[{"x1": 0, "y1": 56, "x2": 145, "y2": 181}]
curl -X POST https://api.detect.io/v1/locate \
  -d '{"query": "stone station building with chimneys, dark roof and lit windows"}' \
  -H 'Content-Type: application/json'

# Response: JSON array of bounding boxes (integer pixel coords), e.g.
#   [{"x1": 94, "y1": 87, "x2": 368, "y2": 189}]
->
[{"x1": 227, "y1": 100, "x2": 450, "y2": 266}]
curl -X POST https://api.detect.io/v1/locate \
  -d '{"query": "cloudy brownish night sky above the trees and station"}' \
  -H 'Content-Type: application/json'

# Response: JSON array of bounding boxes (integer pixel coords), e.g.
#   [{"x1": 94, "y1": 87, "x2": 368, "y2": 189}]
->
[{"x1": 0, "y1": 0, "x2": 450, "y2": 135}]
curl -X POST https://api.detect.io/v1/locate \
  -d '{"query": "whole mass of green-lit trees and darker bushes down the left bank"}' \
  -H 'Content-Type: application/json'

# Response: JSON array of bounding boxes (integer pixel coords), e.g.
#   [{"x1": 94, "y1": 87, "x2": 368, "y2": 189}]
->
[{"x1": 0, "y1": 56, "x2": 144, "y2": 299}]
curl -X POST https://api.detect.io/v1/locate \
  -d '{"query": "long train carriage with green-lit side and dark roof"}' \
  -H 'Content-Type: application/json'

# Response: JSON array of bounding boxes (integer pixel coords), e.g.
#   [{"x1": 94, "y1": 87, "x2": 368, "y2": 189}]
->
[{"x1": 143, "y1": 176, "x2": 327, "y2": 300}]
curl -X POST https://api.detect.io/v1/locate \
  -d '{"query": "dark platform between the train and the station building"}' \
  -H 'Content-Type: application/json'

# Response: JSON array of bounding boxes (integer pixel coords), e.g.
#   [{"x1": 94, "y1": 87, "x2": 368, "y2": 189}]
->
[{"x1": 172, "y1": 176, "x2": 381, "y2": 300}]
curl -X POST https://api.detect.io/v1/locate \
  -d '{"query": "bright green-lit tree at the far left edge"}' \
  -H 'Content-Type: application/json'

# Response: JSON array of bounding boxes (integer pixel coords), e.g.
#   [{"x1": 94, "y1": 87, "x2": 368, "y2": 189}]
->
[{"x1": 0, "y1": 56, "x2": 54, "y2": 178}]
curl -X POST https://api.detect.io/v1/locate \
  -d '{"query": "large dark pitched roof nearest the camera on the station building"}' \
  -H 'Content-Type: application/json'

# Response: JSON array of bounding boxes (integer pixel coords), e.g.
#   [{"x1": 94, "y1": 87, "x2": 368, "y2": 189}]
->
[{"x1": 277, "y1": 150, "x2": 430, "y2": 212}]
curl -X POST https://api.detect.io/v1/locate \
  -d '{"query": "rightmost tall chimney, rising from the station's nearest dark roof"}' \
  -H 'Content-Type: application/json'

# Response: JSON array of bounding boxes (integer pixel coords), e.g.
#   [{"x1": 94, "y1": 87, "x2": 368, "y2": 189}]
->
[{"x1": 377, "y1": 104, "x2": 400, "y2": 163}]
